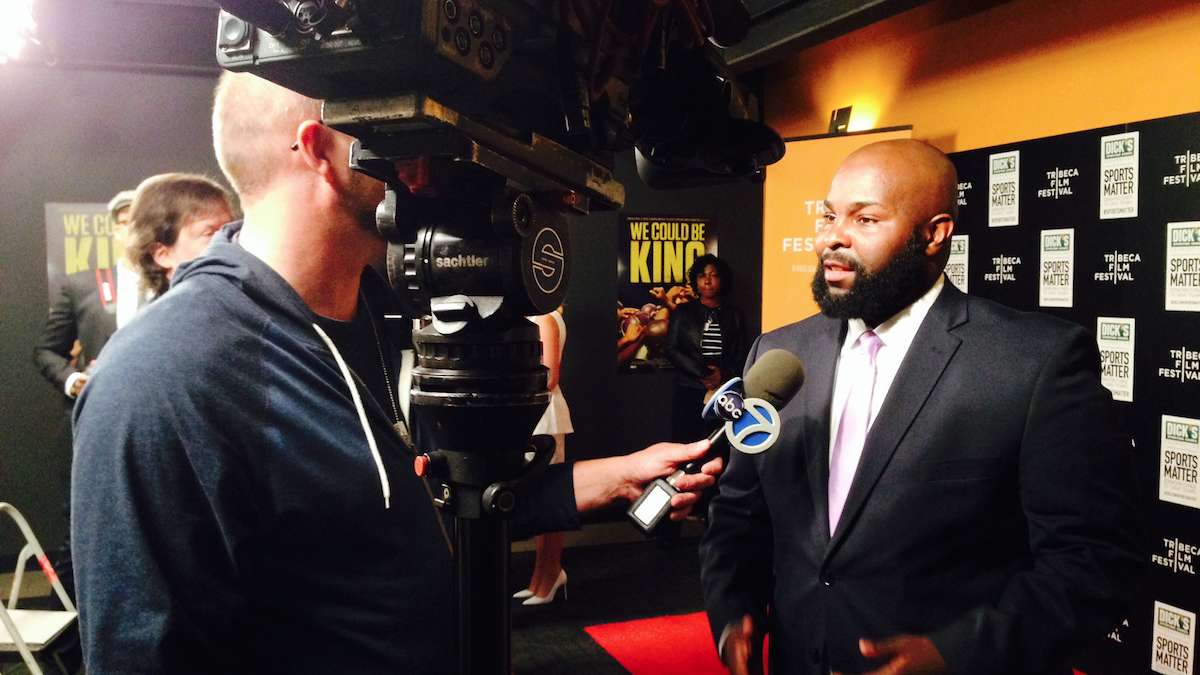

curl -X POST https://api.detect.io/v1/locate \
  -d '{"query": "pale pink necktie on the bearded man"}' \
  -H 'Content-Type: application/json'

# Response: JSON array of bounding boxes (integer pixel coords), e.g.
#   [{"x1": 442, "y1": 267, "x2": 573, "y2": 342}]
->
[{"x1": 829, "y1": 330, "x2": 883, "y2": 534}]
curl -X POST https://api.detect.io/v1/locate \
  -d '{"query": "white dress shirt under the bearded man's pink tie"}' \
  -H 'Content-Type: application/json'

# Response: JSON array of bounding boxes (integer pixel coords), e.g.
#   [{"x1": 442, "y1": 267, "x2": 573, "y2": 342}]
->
[{"x1": 829, "y1": 275, "x2": 946, "y2": 456}]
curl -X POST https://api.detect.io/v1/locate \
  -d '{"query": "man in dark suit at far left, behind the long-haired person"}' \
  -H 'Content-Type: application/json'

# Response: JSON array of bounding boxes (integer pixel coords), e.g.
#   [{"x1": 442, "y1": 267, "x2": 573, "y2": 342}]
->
[{"x1": 34, "y1": 190, "x2": 133, "y2": 398}]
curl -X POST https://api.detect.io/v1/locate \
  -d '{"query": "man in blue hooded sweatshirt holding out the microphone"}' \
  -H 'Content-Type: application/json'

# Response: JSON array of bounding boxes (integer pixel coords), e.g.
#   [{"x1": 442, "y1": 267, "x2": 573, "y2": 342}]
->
[{"x1": 73, "y1": 73, "x2": 720, "y2": 675}]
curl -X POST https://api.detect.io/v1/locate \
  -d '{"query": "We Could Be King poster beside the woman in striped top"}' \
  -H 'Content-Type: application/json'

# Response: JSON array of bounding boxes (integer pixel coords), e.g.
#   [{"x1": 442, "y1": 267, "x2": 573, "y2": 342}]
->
[{"x1": 617, "y1": 216, "x2": 716, "y2": 372}]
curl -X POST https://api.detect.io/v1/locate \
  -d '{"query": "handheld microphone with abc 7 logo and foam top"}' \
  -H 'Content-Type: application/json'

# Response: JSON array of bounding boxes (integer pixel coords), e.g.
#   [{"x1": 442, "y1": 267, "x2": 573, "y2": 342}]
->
[{"x1": 628, "y1": 350, "x2": 804, "y2": 533}]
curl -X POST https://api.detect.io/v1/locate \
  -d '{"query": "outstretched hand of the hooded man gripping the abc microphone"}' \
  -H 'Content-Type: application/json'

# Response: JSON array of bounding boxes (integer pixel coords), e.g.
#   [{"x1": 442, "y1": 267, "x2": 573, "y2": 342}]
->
[{"x1": 574, "y1": 441, "x2": 724, "y2": 520}]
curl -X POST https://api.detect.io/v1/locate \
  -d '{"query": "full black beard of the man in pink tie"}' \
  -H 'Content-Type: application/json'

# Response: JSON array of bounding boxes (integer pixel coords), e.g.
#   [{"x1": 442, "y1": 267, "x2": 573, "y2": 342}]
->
[{"x1": 812, "y1": 231, "x2": 929, "y2": 327}]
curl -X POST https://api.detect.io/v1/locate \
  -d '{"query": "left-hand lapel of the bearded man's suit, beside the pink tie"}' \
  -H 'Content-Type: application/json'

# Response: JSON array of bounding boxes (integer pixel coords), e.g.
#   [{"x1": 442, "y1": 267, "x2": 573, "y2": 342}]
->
[{"x1": 803, "y1": 319, "x2": 846, "y2": 540}]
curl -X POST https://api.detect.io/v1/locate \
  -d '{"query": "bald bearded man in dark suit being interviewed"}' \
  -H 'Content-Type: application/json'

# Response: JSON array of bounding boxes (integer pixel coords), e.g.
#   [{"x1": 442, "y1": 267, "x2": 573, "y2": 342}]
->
[{"x1": 701, "y1": 141, "x2": 1144, "y2": 675}]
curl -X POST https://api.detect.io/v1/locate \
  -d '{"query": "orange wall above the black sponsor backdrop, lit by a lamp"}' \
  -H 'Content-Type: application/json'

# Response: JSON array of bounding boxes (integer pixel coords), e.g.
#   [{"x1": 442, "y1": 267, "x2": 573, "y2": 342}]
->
[{"x1": 766, "y1": 0, "x2": 1200, "y2": 153}]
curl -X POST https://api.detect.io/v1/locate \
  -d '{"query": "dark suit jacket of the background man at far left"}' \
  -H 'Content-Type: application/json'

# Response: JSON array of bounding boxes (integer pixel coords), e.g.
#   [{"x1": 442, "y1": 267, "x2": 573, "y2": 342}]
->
[{"x1": 34, "y1": 270, "x2": 116, "y2": 393}]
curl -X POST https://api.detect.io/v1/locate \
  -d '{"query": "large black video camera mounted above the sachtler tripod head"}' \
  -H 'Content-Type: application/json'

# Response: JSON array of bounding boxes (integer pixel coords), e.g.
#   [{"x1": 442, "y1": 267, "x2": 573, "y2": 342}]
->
[{"x1": 217, "y1": 0, "x2": 784, "y2": 198}]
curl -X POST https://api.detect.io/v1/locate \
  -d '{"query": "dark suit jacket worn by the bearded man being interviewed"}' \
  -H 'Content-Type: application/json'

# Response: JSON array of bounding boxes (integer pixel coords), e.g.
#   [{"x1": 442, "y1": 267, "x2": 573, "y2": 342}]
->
[{"x1": 701, "y1": 283, "x2": 1144, "y2": 675}]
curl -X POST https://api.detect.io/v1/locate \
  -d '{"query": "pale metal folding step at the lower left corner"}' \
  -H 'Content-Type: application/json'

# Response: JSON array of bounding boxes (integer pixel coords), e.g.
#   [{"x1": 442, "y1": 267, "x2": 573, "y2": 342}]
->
[{"x1": 0, "y1": 502, "x2": 78, "y2": 675}]
